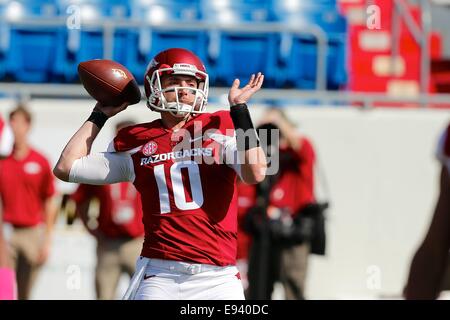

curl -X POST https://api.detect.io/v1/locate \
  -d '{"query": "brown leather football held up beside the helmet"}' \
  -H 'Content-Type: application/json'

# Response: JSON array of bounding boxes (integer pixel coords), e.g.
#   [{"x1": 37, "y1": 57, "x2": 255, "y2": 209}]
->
[{"x1": 78, "y1": 59, "x2": 141, "y2": 106}]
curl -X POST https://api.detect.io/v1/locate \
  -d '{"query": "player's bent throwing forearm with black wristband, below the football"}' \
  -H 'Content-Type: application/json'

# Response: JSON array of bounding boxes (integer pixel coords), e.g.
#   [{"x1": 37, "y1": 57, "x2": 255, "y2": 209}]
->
[{"x1": 53, "y1": 103, "x2": 128, "y2": 182}]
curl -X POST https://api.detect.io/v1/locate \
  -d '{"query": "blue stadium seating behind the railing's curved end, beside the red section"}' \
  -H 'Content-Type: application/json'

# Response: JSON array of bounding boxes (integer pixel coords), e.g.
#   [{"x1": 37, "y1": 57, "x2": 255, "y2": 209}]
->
[{"x1": 274, "y1": 0, "x2": 347, "y2": 90}]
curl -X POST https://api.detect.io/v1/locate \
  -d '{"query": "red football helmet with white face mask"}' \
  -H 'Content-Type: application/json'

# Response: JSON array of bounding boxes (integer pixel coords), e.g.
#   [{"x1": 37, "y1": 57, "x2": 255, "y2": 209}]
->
[{"x1": 145, "y1": 48, "x2": 209, "y2": 118}]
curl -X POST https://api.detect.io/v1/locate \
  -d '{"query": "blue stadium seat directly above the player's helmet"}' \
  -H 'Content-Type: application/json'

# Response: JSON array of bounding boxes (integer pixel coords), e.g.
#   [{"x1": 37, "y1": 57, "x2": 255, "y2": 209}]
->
[{"x1": 125, "y1": 0, "x2": 208, "y2": 83}]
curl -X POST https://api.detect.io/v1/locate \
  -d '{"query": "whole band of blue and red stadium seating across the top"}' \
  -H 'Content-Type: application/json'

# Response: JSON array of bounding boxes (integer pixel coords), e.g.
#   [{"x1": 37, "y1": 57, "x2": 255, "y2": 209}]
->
[{"x1": 0, "y1": 0, "x2": 442, "y2": 94}]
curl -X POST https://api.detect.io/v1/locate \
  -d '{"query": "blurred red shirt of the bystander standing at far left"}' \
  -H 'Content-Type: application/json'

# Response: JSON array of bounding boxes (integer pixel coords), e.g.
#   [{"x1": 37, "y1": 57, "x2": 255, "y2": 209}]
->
[{"x1": 0, "y1": 149, "x2": 55, "y2": 227}]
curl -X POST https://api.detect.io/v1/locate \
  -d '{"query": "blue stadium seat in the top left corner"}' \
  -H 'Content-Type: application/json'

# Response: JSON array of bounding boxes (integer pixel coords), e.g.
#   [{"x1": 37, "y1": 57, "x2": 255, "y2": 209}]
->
[{"x1": 2, "y1": 0, "x2": 60, "y2": 82}]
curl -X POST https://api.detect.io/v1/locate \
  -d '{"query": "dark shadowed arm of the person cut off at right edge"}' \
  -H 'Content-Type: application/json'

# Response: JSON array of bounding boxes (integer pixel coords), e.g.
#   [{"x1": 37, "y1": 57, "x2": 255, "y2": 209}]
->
[{"x1": 404, "y1": 166, "x2": 450, "y2": 299}]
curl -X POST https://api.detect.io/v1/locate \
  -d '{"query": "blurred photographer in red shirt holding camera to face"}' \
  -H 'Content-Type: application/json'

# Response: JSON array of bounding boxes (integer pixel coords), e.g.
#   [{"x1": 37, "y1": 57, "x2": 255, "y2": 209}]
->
[{"x1": 246, "y1": 108, "x2": 325, "y2": 300}]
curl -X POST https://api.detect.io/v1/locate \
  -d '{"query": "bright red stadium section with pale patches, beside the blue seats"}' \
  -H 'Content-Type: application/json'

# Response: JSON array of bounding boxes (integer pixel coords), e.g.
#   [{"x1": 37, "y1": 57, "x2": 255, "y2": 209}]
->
[{"x1": 339, "y1": 0, "x2": 442, "y2": 105}]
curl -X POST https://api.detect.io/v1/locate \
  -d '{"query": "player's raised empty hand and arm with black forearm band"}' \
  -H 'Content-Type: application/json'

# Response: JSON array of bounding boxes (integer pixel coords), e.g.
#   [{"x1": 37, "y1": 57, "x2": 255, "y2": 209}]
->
[{"x1": 228, "y1": 73, "x2": 267, "y2": 184}]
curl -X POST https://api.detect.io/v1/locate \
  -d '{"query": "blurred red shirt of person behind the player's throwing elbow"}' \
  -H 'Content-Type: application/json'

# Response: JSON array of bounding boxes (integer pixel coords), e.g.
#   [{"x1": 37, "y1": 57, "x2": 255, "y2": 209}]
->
[{"x1": 71, "y1": 182, "x2": 144, "y2": 238}]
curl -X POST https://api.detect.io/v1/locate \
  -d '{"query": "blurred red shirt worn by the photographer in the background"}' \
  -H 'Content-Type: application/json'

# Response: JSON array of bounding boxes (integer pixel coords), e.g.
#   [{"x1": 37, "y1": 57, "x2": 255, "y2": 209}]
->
[{"x1": 270, "y1": 138, "x2": 315, "y2": 214}]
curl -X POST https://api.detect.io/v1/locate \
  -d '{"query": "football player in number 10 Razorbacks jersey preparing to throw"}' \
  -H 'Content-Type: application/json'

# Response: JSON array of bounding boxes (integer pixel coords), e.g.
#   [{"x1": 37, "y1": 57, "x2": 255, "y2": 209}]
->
[{"x1": 54, "y1": 48, "x2": 267, "y2": 300}]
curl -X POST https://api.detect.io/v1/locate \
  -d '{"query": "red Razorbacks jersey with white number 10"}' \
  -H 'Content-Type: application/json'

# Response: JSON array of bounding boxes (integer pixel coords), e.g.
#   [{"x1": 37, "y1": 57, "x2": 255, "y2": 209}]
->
[{"x1": 110, "y1": 111, "x2": 237, "y2": 266}]
